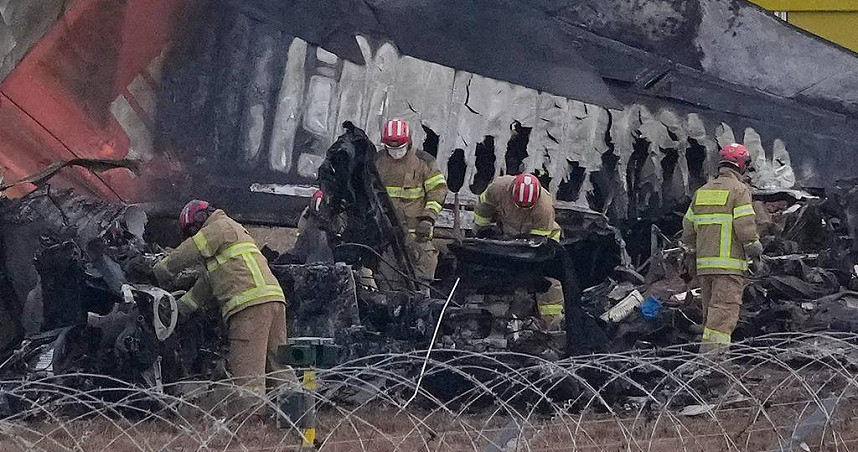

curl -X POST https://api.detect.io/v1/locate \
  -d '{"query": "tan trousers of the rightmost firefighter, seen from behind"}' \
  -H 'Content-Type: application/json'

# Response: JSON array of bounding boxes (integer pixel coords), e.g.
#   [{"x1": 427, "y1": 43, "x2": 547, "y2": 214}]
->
[{"x1": 699, "y1": 275, "x2": 745, "y2": 345}]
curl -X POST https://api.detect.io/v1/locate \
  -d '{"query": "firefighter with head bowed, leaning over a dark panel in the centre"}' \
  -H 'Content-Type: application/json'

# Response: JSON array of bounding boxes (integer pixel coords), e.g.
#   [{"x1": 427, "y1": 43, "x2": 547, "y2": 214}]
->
[{"x1": 474, "y1": 174, "x2": 564, "y2": 330}]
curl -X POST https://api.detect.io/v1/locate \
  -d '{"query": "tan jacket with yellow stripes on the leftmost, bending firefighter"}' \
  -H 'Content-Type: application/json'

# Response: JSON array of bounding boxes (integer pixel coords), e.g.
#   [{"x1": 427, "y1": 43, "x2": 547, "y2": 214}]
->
[{"x1": 154, "y1": 210, "x2": 286, "y2": 320}]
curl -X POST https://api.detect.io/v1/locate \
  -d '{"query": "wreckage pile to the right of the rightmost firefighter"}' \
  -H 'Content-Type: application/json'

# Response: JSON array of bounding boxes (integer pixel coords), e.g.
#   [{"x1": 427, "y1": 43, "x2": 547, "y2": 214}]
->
[{"x1": 739, "y1": 180, "x2": 858, "y2": 337}]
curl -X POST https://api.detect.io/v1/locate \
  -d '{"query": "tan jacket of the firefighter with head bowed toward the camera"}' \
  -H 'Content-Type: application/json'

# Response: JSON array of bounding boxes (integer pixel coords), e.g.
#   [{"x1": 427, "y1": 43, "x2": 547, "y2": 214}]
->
[{"x1": 474, "y1": 176, "x2": 561, "y2": 242}]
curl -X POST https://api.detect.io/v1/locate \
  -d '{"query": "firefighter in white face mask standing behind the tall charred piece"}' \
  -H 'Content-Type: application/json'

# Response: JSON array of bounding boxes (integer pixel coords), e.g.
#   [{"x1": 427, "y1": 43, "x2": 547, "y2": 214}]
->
[{"x1": 375, "y1": 119, "x2": 447, "y2": 288}]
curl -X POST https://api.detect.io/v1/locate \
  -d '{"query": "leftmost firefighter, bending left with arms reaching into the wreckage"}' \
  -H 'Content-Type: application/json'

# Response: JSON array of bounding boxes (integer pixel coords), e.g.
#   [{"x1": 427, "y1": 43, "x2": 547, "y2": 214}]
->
[{"x1": 154, "y1": 200, "x2": 295, "y2": 400}]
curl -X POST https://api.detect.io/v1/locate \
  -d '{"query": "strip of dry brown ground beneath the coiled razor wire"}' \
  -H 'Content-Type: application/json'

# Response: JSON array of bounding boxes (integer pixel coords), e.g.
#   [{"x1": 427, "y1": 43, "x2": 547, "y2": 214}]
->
[{"x1": 0, "y1": 399, "x2": 858, "y2": 452}]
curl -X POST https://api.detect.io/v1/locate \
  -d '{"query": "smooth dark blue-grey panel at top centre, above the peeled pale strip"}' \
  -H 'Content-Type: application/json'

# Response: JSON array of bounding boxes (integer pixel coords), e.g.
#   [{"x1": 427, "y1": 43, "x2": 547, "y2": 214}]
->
[{"x1": 234, "y1": 0, "x2": 620, "y2": 107}]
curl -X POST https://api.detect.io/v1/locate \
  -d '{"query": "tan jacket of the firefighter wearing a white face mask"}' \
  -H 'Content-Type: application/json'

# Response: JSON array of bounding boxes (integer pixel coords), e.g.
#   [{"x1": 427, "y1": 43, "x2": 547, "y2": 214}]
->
[{"x1": 375, "y1": 148, "x2": 447, "y2": 232}]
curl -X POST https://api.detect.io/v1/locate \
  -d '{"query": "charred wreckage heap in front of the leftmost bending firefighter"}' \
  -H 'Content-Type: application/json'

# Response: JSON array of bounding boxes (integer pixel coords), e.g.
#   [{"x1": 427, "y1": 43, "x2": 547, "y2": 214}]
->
[{"x1": 0, "y1": 185, "x2": 223, "y2": 414}]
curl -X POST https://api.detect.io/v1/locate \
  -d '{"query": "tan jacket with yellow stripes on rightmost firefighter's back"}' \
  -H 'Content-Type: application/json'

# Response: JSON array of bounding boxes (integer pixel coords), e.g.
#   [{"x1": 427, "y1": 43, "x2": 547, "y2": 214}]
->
[{"x1": 682, "y1": 168, "x2": 759, "y2": 275}]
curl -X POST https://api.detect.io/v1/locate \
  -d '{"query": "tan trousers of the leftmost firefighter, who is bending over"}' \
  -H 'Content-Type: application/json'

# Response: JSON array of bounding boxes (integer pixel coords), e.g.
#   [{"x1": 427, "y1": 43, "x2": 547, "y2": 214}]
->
[{"x1": 228, "y1": 302, "x2": 299, "y2": 402}]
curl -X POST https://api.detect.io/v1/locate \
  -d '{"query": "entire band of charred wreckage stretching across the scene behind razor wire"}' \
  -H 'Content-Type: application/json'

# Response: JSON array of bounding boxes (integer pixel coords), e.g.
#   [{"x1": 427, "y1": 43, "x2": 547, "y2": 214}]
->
[{"x1": 0, "y1": 127, "x2": 858, "y2": 430}]
